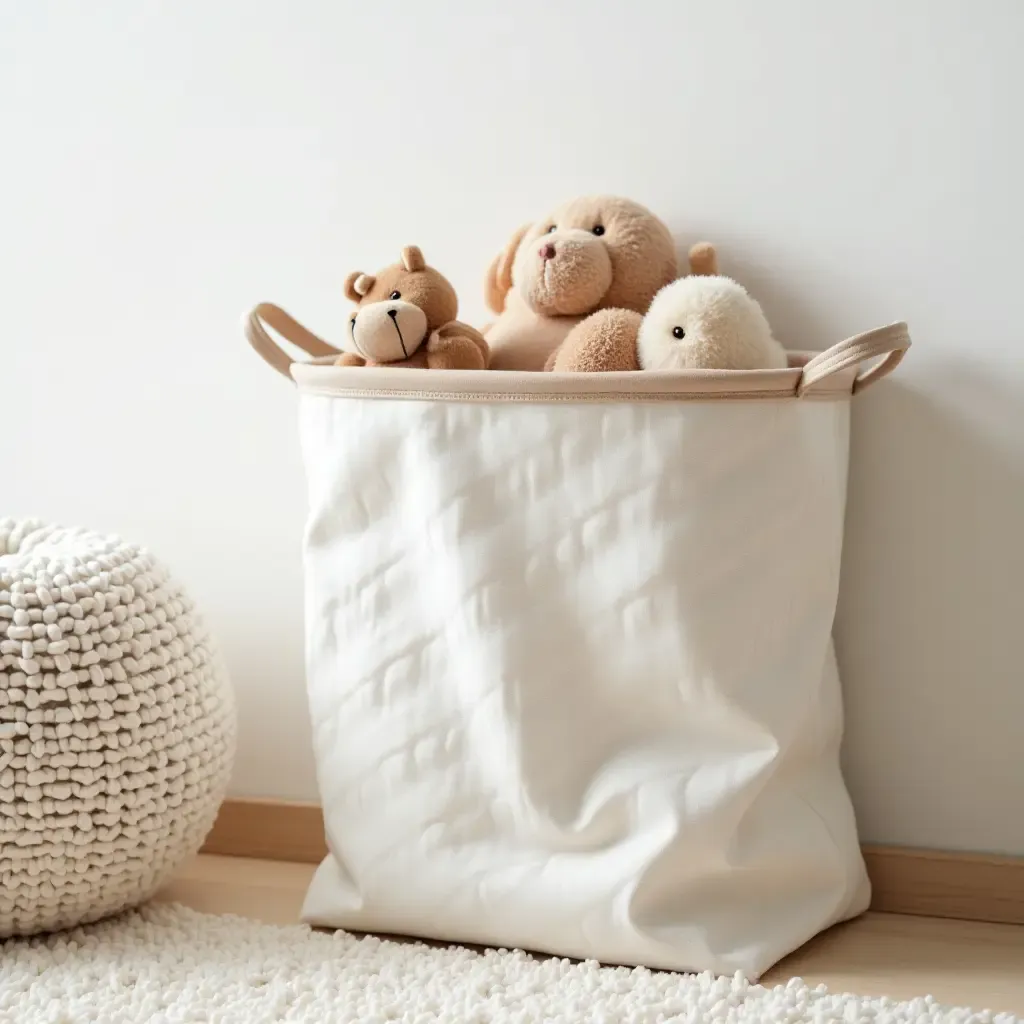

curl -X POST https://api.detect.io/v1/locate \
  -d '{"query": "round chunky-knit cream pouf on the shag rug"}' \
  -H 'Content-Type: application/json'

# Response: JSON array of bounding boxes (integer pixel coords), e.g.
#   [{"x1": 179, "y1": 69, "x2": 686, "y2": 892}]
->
[{"x1": 0, "y1": 519, "x2": 236, "y2": 936}]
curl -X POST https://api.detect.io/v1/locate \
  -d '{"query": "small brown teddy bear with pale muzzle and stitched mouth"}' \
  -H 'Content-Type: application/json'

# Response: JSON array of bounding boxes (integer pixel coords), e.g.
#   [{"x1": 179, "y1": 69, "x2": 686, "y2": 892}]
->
[{"x1": 335, "y1": 246, "x2": 489, "y2": 370}]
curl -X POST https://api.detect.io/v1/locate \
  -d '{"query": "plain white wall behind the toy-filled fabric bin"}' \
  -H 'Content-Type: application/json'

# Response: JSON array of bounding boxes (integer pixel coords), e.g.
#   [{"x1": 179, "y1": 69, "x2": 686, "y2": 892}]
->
[{"x1": 0, "y1": 0, "x2": 1024, "y2": 853}]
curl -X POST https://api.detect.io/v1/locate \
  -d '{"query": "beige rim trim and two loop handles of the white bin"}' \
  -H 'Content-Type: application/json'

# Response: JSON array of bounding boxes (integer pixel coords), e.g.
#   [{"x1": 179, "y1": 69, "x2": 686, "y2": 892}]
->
[{"x1": 244, "y1": 302, "x2": 910, "y2": 402}]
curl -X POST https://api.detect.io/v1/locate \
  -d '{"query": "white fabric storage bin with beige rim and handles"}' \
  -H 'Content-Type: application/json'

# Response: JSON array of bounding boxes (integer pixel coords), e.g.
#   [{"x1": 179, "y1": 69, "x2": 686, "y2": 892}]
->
[{"x1": 249, "y1": 306, "x2": 909, "y2": 978}]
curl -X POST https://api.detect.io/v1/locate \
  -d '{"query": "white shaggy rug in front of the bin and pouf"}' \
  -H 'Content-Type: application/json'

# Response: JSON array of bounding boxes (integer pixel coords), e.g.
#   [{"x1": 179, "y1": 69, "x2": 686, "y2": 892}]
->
[{"x1": 0, "y1": 904, "x2": 1022, "y2": 1024}]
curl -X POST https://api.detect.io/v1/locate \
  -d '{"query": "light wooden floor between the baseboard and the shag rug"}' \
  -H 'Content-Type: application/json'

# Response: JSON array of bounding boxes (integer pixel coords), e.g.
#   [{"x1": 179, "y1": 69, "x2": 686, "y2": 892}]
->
[{"x1": 161, "y1": 856, "x2": 1024, "y2": 1017}]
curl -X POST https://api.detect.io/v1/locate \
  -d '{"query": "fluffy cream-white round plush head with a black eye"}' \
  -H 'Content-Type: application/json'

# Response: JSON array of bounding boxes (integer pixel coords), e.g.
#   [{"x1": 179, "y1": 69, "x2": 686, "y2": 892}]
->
[{"x1": 637, "y1": 276, "x2": 786, "y2": 370}]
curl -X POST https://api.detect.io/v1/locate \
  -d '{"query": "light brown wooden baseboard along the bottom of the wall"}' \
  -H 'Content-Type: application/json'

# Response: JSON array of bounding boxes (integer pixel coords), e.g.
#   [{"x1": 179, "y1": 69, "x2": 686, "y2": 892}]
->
[{"x1": 203, "y1": 800, "x2": 1024, "y2": 925}]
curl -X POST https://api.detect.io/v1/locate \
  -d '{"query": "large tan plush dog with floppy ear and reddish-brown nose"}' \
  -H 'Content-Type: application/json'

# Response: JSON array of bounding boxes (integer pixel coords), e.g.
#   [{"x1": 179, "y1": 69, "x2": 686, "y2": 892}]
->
[{"x1": 483, "y1": 196, "x2": 714, "y2": 370}]
